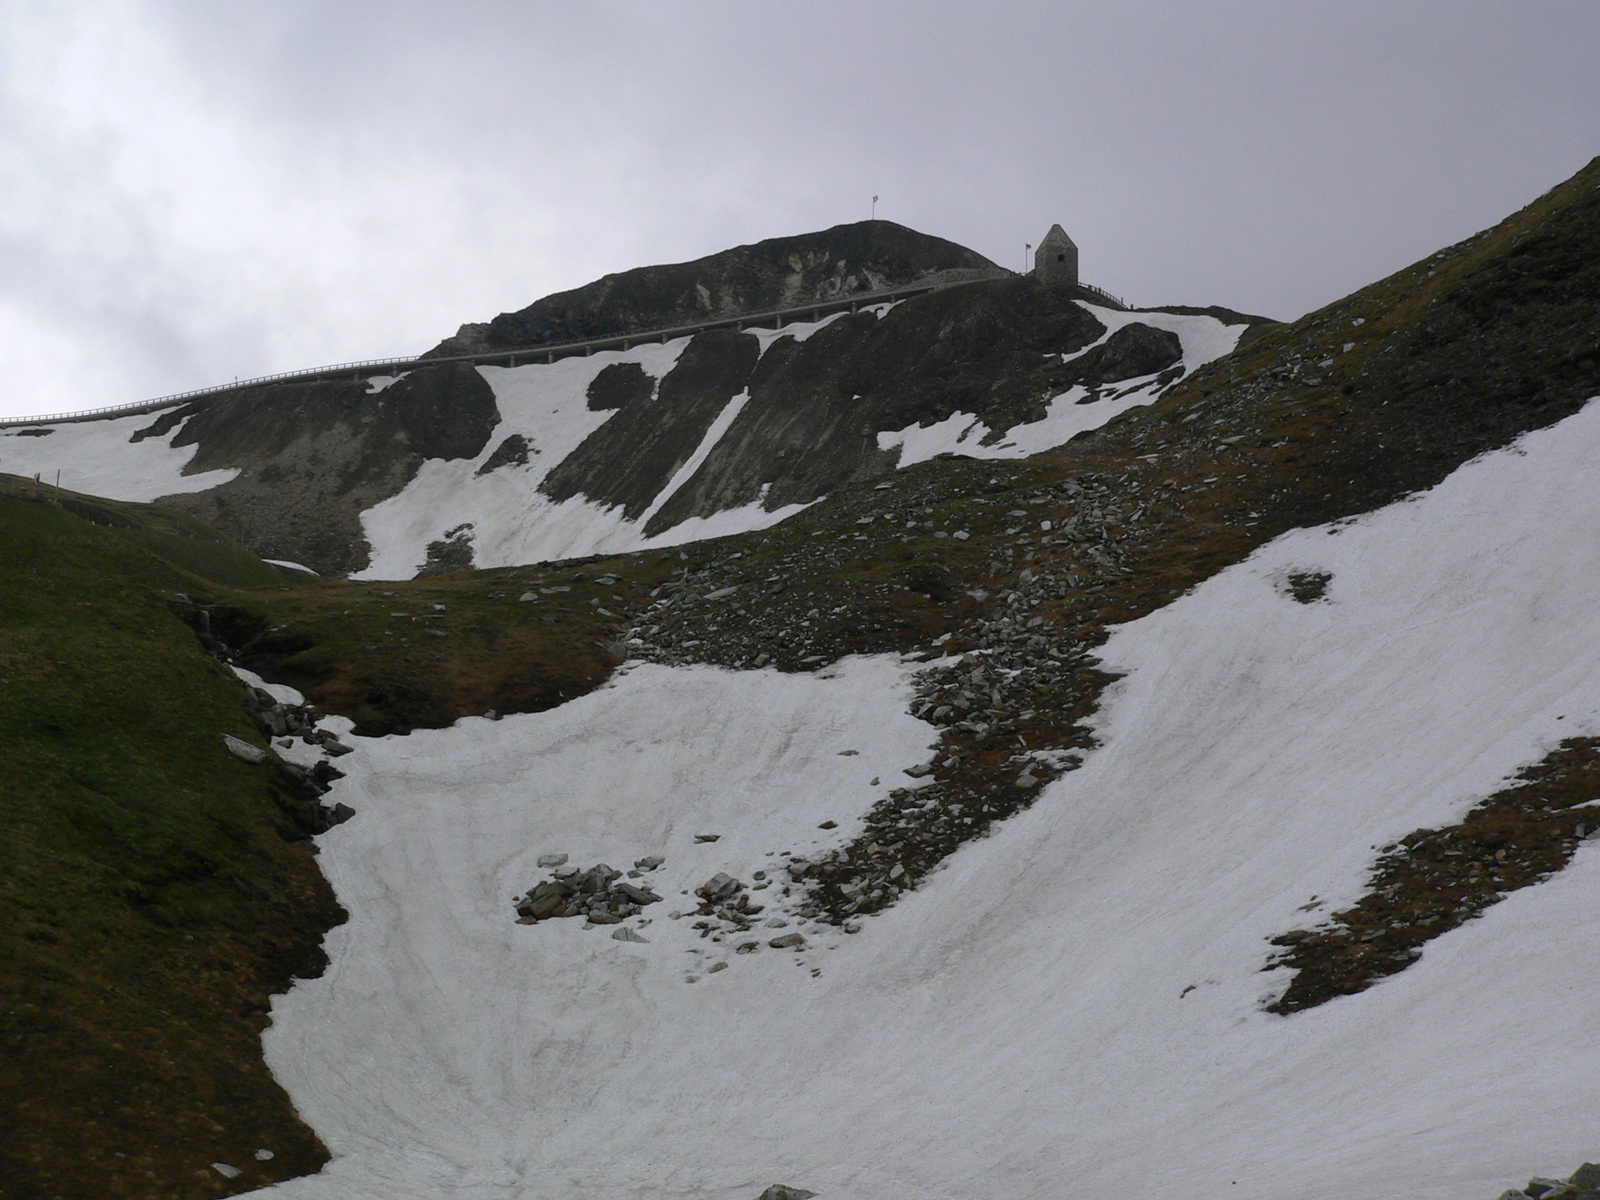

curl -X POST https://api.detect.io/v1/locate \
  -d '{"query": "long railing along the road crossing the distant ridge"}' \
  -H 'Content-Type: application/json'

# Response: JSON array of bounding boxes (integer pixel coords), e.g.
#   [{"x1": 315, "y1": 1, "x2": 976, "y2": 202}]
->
[{"x1": 0, "y1": 272, "x2": 1128, "y2": 429}]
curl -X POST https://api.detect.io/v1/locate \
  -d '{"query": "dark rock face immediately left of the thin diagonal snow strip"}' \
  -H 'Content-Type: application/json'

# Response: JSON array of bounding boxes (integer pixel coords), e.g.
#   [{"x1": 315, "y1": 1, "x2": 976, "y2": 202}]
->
[{"x1": 539, "y1": 330, "x2": 760, "y2": 520}]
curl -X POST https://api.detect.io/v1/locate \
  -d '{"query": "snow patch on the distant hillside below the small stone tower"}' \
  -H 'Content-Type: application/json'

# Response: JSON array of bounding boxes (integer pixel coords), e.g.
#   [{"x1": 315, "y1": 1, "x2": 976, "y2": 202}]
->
[{"x1": 878, "y1": 301, "x2": 1246, "y2": 467}]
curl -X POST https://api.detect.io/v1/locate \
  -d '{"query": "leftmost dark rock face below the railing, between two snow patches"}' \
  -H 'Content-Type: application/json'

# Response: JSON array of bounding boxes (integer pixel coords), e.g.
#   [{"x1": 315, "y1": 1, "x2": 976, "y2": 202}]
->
[{"x1": 152, "y1": 363, "x2": 499, "y2": 574}]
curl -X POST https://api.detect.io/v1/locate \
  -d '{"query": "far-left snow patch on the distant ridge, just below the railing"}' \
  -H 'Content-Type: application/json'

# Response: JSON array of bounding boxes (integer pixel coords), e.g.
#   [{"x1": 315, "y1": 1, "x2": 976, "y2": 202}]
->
[{"x1": 0, "y1": 413, "x2": 238, "y2": 504}]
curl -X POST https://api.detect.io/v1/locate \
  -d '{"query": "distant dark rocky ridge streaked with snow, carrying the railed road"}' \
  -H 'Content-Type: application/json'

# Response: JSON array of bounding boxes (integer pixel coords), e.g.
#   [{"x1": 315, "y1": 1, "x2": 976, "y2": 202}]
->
[{"x1": 0, "y1": 222, "x2": 1270, "y2": 579}]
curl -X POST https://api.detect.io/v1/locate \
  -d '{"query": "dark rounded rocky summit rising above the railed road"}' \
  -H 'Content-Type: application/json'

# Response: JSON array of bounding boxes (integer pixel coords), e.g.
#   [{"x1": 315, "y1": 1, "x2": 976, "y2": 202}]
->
[{"x1": 448, "y1": 221, "x2": 1008, "y2": 355}]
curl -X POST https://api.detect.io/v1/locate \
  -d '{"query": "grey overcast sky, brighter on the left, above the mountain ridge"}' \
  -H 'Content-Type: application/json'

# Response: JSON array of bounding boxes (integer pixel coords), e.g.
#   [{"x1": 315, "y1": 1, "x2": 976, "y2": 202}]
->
[{"x1": 0, "y1": 0, "x2": 1600, "y2": 414}]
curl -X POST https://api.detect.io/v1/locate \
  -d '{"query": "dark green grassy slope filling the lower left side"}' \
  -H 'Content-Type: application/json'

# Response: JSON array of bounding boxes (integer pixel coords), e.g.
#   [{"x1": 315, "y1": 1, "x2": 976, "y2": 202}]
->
[{"x1": 0, "y1": 486, "x2": 339, "y2": 1200}]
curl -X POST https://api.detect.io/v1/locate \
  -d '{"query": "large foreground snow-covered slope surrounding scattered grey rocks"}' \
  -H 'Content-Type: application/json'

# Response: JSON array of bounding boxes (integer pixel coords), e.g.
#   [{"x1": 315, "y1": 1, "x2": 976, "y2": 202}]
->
[{"x1": 246, "y1": 403, "x2": 1600, "y2": 1200}]
